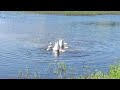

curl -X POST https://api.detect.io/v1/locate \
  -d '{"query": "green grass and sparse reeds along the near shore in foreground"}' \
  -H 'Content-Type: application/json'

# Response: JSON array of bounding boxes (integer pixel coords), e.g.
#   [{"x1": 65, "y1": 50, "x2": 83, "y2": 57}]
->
[{"x1": 19, "y1": 62, "x2": 120, "y2": 79}]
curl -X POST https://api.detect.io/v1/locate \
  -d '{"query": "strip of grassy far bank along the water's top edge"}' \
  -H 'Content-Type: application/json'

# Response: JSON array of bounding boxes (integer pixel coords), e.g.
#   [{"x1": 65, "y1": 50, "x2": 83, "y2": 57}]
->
[{"x1": 22, "y1": 11, "x2": 120, "y2": 16}]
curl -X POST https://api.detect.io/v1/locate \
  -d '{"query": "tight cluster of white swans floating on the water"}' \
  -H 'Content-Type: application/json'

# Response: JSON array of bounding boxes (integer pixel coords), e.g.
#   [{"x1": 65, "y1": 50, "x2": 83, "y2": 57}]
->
[{"x1": 47, "y1": 39, "x2": 68, "y2": 53}]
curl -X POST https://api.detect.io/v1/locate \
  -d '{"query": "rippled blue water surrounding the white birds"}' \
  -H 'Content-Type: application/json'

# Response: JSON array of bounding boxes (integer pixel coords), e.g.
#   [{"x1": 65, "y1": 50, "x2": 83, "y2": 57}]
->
[{"x1": 0, "y1": 12, "x2": 120, "y2": 78}]
